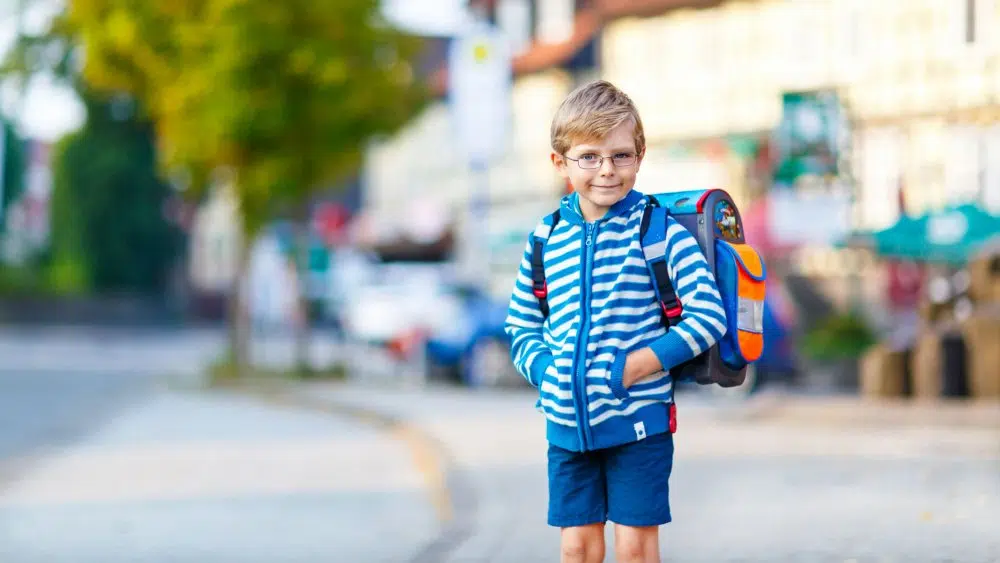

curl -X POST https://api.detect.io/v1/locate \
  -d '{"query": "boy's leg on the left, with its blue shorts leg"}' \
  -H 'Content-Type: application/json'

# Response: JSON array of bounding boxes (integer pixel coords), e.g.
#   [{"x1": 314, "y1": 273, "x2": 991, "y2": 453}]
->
[{"x1": 548, "y1": 444, "x2": 608, "y2": 563}]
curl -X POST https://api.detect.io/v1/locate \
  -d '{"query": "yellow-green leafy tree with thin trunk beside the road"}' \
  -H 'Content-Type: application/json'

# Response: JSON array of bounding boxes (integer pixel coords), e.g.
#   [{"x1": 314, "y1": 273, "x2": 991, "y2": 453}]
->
[{"x1": 65, "y1": 0, "x2": 424, "y2": 378}]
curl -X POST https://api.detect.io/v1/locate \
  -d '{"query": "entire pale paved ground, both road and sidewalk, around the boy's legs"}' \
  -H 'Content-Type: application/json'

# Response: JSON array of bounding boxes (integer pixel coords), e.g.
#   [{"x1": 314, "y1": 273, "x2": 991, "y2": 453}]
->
[{"x1": 0, "y1": 329, "x2": 1000, "y2": 563}]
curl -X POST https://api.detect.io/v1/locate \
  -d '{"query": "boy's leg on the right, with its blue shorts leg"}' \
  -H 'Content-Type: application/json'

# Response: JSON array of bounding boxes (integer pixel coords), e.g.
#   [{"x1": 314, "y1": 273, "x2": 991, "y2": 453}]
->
[{"x1": 604, "y1": 432, "x2": 674, "y2": 563}]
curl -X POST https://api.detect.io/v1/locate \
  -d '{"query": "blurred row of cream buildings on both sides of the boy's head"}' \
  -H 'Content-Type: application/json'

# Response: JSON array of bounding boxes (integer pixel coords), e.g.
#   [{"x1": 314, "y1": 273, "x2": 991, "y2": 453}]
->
[{"x1": 363, "y1": 0, "x2": 1000, "y2": 310}]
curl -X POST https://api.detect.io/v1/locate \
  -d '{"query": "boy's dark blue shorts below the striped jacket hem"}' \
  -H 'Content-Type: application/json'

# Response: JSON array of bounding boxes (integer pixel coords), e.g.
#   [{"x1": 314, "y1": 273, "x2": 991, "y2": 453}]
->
[{"x1": 548, "y1": 432, "x2": 674, "y2": 528}]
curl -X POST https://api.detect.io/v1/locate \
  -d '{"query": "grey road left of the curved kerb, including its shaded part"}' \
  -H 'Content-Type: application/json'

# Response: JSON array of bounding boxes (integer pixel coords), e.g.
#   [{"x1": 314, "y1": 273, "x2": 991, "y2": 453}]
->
[{"x1": 0, "y1": 334, "x2": 439, "y2": 563}]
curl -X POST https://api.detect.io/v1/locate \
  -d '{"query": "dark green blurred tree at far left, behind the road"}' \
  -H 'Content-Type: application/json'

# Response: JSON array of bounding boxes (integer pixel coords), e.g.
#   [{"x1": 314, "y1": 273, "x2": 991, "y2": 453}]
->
[{"x1": 52, "y1": 94, "x2": 182, "y2": 294}]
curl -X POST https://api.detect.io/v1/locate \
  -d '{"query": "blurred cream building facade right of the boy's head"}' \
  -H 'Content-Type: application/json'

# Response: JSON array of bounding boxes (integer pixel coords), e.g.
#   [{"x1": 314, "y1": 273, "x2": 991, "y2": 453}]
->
[{"x1": 601, "y1": 0, "x2": 1000, "y2": 308}]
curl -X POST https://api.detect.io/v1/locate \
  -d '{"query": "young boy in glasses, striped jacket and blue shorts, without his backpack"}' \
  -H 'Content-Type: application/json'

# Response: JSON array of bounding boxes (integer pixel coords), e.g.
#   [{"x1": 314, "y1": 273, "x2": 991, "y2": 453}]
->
[{"x1": 506, "y1": 81, "x2": 726, "y2": 563}]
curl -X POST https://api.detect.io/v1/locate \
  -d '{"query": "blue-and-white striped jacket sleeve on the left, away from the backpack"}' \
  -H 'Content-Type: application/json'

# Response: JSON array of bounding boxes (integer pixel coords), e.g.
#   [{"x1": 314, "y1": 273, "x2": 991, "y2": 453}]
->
[{"x1": 504, "y1": 230, "x2": 554, "y2": 387}]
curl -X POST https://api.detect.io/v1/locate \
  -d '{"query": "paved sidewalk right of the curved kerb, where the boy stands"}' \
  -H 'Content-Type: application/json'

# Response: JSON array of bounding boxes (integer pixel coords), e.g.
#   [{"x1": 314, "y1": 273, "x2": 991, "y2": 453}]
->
[{"x1": 274, "y1": 384, "x2": 1000, "y2": 563}]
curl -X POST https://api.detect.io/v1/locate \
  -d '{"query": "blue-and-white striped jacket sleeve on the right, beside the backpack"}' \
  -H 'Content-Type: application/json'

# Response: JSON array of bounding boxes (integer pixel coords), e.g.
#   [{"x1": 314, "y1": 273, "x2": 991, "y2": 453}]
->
[{"x1": 650, "y1": 217, "x2": 726, "y2": 370}]
